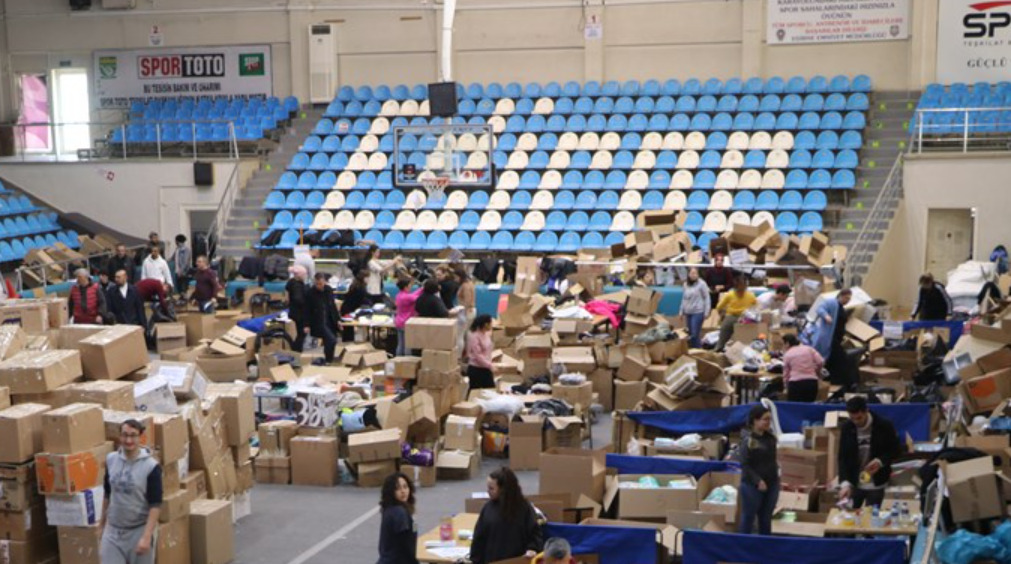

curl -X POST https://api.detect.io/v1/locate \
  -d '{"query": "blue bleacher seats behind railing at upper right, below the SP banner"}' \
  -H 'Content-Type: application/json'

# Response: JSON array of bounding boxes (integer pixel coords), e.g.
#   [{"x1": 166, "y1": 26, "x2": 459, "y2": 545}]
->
[{"x1": 909, "y1": 82, "x2": 1011, "y2": 136}]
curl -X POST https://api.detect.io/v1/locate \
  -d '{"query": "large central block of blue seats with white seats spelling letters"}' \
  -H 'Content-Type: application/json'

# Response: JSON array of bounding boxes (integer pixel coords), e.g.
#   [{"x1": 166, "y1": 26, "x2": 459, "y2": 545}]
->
[{"x1": 261, "y1": 76, "x2": 870, "y2": 251}]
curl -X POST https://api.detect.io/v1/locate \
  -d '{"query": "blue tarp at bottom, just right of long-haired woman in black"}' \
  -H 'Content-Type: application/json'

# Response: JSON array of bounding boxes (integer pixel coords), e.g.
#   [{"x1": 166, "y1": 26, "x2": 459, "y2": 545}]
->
[{"x1": 545, "y1": 523, "x2": 656, "y2": 564}]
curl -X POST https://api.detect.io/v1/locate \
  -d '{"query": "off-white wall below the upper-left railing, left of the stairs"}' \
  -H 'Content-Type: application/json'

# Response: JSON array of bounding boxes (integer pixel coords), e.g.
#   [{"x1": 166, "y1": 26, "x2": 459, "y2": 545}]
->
[{"x1": 0, "y1": 161, "x2": 258, "y2": 240}]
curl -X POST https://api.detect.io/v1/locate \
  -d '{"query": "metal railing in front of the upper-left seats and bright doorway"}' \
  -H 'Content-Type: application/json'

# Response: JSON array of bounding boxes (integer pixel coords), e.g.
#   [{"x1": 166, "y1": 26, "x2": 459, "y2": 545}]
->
[{"x1": 0, "y1": 119, "x2": 254, "y2": 162}]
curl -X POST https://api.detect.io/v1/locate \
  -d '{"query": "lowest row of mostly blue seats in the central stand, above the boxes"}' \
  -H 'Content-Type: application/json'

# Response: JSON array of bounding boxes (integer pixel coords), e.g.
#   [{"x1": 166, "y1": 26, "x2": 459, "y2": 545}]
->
[{"x1": 258, "y1": 211, "x2": 822, "y2": 252}]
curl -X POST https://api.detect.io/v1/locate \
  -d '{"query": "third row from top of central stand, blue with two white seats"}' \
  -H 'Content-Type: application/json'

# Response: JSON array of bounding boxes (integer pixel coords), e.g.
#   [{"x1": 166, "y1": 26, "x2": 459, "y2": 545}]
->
[{"x1": 312, "y1": 110, "x2": 866, "y2": 135}]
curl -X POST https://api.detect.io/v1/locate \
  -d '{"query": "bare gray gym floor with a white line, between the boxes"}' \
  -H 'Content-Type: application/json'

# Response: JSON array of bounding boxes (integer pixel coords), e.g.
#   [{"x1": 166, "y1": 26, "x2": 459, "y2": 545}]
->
[{"x1": 236, "y1": 415, "x2": 611, "y2": 564}]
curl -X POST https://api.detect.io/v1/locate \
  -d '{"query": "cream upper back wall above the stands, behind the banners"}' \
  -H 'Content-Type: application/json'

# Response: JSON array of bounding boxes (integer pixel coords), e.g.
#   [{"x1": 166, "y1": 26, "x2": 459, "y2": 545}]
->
[{"x1": 0, "y1": 0, "x2": 939, "y2": 121}]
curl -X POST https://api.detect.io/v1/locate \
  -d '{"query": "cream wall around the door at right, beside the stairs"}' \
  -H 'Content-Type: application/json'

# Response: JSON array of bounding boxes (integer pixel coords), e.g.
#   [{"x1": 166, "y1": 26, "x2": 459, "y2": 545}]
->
[{"x1": 865, "y1": 153, "x2": 1011, "y2": 305}]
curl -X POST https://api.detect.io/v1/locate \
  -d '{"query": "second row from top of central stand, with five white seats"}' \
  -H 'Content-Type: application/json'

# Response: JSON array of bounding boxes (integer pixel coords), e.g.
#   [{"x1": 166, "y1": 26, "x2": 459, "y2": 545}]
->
[{"x1": 324, "y1": 92, "x2": 869, "y2": 117}]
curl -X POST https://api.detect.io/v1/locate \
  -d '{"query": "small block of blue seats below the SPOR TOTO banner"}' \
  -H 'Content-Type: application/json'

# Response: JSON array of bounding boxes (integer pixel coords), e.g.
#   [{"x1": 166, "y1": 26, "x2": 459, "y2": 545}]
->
[{"x1": 108, "y1": 96, "x2": 299, "y2": 154}]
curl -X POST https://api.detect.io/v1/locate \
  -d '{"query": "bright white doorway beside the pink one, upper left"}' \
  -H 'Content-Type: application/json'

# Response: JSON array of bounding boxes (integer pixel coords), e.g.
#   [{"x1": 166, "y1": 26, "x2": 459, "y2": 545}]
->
[{"x1": 53, "y1": 69, "x2": 91, "y2": 155}]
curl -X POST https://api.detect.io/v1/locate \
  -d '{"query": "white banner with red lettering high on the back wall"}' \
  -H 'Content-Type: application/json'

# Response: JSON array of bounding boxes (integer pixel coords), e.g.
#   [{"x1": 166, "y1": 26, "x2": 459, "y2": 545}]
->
[{"x1": 765, "y1": 0, "x2": 913, "y2": 45}]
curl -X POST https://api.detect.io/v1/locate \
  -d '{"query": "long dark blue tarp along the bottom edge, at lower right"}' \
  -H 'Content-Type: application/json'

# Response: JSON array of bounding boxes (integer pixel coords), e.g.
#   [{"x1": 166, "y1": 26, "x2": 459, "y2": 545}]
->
[{"x1": 679, "y1": 531, "x2": 906, "y2": 564}]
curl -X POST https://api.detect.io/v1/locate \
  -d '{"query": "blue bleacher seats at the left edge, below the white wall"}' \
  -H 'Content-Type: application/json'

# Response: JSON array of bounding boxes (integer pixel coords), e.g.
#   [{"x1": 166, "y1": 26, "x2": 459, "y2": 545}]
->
[{"x1": 0, "y1": 182, "x2": 80, "y2": 263}]
